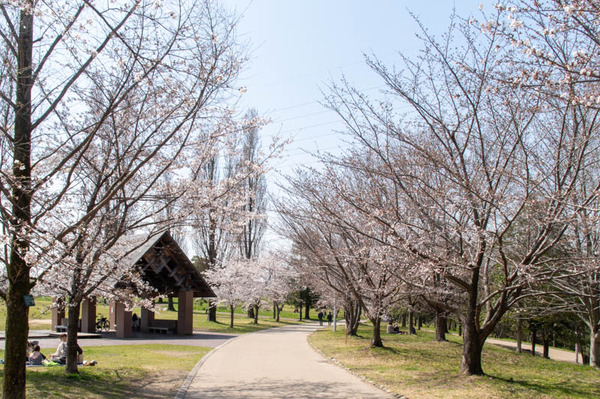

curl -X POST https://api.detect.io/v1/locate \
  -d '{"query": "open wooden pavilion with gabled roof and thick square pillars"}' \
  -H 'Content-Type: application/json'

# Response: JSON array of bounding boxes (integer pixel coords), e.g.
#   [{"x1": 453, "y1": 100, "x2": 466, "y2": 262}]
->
[{"x1": 52, "y1": 232, "x2": 216, "y2": 338}]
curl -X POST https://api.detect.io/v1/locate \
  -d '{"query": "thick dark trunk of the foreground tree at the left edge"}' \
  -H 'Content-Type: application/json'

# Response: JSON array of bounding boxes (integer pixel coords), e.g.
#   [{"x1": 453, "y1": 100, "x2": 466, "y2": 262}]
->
[{"x1": 2, "y1": 8, "x2": 34, "y2": 399}]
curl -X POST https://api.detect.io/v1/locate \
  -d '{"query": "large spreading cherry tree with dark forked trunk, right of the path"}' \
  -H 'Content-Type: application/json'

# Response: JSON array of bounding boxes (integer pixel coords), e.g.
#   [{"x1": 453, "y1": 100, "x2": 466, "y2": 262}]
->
[{"x1": 318, "y1": 12, "x2": 598, "y2": 374}]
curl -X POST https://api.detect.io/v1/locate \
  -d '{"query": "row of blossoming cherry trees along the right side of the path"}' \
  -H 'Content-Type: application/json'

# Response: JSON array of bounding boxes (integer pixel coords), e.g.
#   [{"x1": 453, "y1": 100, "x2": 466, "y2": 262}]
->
[{"x1": 278, "y1": 0, "x2": 600, "y2": 374}]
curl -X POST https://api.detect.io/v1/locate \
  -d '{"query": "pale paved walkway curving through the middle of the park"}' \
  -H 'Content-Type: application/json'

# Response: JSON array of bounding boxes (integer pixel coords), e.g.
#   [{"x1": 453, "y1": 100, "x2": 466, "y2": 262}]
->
[{"x1": 184, "y1": 323, "x2": 392, "y2": 399}]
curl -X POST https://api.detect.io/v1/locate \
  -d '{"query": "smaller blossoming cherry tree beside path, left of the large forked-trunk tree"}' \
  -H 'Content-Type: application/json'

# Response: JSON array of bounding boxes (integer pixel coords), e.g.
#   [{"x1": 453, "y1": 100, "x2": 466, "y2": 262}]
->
[{"x1": 279, "y1": 168, "x2": 402, "y2": 347}]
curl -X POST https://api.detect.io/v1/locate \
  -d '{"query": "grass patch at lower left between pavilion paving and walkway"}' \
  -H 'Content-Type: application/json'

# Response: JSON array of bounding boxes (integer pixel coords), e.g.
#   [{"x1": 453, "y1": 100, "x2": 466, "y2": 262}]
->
[{"x1": 0, "y1": 344, "x2": 212, "y2": 398}]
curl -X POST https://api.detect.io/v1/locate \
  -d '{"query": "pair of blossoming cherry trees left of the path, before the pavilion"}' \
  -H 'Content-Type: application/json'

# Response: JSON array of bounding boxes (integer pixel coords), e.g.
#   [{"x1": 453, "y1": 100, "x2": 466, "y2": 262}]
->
[{"x1": 0, "y1": 0, "x2": 278, "y2": 398}]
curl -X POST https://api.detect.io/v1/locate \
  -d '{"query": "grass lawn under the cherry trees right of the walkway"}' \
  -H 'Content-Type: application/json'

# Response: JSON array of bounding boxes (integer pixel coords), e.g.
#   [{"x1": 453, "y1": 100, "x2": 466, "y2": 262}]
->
[{"x1": 311, "y1": 325, "x2": 600, "y2": 399}]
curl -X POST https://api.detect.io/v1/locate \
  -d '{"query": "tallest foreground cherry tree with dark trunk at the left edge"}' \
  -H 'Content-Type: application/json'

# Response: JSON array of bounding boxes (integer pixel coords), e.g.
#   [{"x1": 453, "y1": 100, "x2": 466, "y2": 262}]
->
[{"x1": 0, "y1": 0, "x2": 244, "y2": 392}]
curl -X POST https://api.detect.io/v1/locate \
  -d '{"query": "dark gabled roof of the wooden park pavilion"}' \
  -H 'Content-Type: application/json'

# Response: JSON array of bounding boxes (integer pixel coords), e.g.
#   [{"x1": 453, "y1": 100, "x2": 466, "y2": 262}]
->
[{"x1": 127, "y1": 232, "x2": 216, "y2": 298}]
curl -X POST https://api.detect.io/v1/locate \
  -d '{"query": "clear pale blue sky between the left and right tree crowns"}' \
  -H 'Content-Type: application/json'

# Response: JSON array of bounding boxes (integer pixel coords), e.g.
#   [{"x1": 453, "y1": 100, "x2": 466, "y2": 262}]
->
[{"x1": 226, "y1": 0, "x2": 490, "y2": 247}]
